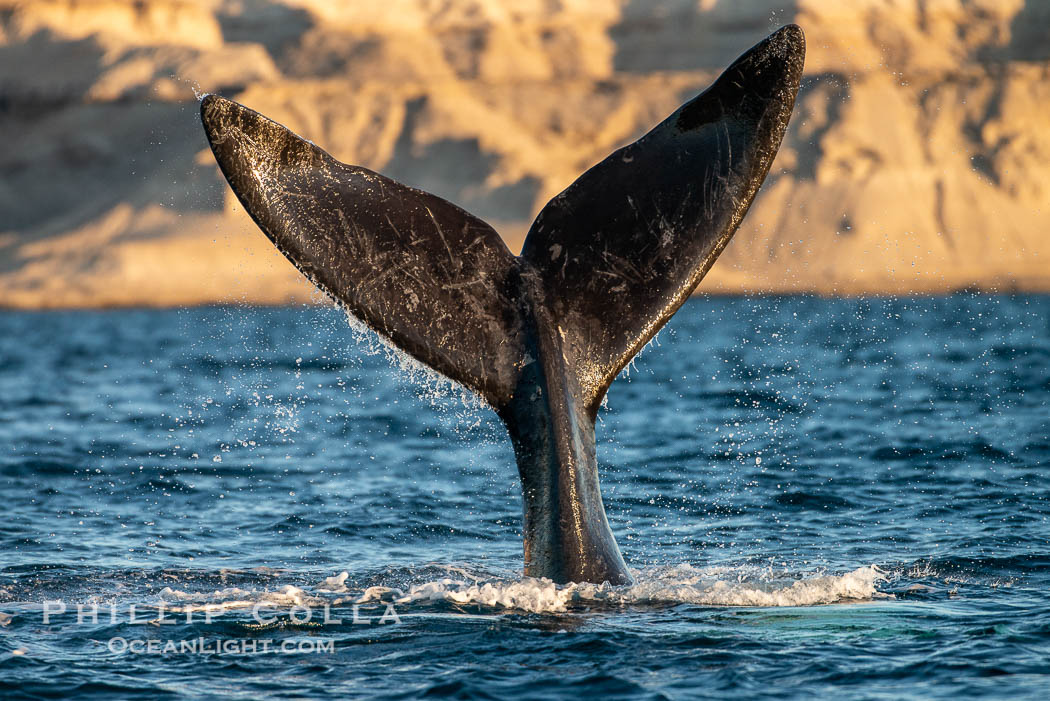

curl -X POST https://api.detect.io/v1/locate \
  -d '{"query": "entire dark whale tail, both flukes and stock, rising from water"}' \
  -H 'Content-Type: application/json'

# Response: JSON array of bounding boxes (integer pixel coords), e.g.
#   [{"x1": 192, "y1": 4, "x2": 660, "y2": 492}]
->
[{"x1": 201, "y1": 25, "x2": 805, "y2": 583}]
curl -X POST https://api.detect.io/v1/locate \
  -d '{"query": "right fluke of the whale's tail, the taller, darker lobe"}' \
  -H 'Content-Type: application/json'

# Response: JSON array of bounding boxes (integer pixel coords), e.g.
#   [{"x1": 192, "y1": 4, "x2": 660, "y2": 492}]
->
[{"x1": 522, "y1": 25, "x2": 805, "y2": 413}]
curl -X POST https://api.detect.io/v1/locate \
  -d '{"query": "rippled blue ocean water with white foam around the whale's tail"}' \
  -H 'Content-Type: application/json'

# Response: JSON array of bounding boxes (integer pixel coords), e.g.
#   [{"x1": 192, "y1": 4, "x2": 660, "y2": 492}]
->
[{"x1": 0, "y1": 294, "x2": 1050, "y2": 699}]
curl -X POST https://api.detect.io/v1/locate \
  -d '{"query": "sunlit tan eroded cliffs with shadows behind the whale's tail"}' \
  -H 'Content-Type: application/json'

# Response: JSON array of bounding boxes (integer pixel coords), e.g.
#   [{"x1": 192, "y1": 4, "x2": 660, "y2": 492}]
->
[{"x1": 0, "y1": 0, "x2": 1050, "y2": 306}]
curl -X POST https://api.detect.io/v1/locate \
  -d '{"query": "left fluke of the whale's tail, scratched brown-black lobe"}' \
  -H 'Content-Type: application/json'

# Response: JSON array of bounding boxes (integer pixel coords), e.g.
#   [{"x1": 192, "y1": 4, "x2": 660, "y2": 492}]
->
[{"x1": 201, "y1": 94, "x2": 522, "y2": 405}]
